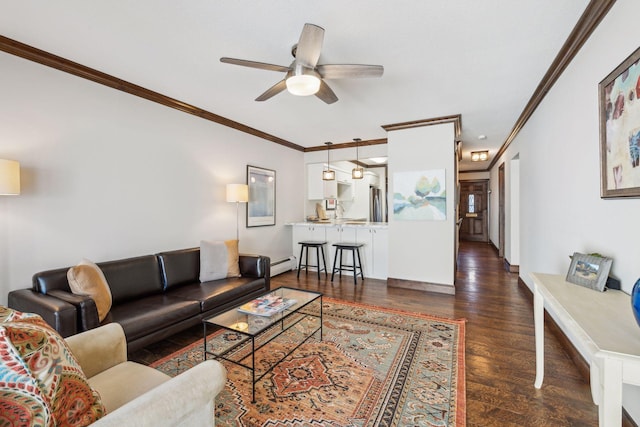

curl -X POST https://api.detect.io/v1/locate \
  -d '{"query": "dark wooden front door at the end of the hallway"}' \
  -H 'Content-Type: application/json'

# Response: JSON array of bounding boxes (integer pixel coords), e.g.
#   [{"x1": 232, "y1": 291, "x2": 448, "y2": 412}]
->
[{"x1": 460, "y1": 179, "x2": 489, "y2": 242}]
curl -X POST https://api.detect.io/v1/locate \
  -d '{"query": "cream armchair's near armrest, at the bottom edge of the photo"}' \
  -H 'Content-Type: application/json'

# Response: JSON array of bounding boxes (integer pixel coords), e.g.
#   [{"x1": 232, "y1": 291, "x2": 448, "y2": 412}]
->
[{"x1": 92, "y1": 360, "x2": 227, "y2": 427}]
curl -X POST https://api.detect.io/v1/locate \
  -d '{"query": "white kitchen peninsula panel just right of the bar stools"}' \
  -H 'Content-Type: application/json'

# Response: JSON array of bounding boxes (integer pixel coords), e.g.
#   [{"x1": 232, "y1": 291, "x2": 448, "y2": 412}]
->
[{"x1": 356, "y1": 227, "x2": 389, "y2": 280}]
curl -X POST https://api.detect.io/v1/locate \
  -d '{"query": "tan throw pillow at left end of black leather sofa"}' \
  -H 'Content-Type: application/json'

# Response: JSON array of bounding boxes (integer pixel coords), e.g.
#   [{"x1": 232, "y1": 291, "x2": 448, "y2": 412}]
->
[{"x1": 67, "y1": 259, "x2": 112, "y2": 322}]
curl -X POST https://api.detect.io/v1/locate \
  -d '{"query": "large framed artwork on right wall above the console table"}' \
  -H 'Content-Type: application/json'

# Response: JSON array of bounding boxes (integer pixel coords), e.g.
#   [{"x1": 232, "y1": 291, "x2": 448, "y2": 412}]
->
[{"x1": 598, "y1": 48, "x2": 640, "y2": 198}]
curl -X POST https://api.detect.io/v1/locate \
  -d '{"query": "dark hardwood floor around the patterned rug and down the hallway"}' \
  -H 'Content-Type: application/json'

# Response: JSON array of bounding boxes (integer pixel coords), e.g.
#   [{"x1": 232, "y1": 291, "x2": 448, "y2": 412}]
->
[{"x1": 131, "y1": 242, "x2": 598, "y2": 427}]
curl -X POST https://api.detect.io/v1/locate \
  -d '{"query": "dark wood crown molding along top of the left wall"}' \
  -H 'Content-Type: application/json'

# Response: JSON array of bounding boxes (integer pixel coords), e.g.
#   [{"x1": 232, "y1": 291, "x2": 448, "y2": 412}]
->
[{"x1": 0, "y1": 35, "x2": 304, "y2": 151}]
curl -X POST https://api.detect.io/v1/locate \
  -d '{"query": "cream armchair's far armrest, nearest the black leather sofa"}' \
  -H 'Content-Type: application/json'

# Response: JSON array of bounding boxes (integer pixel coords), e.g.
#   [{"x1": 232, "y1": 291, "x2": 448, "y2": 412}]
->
[{"x1": 66, "y1": 323, "x2": 127, "y2": 378}]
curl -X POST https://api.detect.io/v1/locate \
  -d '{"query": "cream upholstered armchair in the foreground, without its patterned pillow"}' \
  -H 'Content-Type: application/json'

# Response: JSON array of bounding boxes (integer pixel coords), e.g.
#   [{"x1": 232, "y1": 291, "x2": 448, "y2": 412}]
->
[{"x1": 66, "y1": 323, "x2": 227, "y2": 427}]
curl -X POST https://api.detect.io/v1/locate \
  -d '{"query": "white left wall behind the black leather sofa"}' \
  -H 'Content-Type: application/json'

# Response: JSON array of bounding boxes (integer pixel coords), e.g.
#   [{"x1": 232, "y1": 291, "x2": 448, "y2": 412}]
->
[{"x1": 0, "y1": 53, "x2": 304, "y2": 304}]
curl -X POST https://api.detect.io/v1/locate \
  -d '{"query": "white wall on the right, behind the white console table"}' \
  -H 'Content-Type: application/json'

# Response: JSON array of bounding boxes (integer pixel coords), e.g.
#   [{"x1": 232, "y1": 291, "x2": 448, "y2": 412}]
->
[{"x1": 491, "y1": 0, "x2": 640, "y2": 422}]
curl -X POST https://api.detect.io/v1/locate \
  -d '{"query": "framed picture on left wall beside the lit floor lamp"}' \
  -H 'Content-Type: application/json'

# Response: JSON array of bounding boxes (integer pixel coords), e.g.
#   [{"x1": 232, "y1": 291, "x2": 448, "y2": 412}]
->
[{"x1": 247, "y1": 166, "x2": 276, "y2": 227}]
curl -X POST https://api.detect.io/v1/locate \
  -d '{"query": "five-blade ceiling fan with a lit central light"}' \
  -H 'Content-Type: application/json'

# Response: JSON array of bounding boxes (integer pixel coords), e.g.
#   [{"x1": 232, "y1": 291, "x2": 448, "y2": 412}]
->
[{"x1": 220, "y1": 24, "x2": 384, "y2": 104}]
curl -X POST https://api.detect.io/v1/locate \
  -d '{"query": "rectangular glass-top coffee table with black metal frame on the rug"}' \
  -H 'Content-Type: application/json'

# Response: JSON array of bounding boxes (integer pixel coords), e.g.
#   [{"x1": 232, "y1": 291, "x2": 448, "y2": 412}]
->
[{"x1": 202, "y1": 287, "x2": 322, "y2": 403}]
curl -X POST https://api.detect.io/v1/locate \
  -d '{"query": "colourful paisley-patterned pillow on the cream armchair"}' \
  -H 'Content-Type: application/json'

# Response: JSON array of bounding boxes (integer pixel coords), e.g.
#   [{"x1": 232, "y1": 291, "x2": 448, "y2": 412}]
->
[{"x1": 0, "y1": 306, "x2": 106, "y2": 427}]
